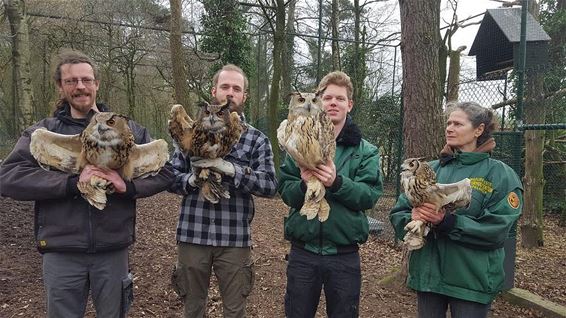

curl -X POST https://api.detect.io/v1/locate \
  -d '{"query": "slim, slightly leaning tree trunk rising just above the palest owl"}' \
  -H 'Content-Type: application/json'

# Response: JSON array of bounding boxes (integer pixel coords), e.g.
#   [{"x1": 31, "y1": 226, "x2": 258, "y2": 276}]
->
[{"x1": 281, "y1": 0, "x2": 297, "y2": 103}]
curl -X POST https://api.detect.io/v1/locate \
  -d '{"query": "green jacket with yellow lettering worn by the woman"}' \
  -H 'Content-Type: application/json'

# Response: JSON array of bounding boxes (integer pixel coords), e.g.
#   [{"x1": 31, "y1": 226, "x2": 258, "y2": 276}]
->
[{"x1": 389, "y1": 152, "x2": 523, "y2": 304}]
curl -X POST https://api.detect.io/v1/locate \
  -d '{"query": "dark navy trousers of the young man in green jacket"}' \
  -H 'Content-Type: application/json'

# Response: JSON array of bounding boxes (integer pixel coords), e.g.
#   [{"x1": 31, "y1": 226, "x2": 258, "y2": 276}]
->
[{"x1": 285, "y1": 246, "x2": 362, "y2": 318}]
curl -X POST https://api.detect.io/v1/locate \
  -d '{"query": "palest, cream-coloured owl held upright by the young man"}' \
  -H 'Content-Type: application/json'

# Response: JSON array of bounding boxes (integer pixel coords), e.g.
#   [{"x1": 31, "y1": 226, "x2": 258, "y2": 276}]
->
[{"x1": 277, "y1": 92, "x2": 336, "y2": 222}]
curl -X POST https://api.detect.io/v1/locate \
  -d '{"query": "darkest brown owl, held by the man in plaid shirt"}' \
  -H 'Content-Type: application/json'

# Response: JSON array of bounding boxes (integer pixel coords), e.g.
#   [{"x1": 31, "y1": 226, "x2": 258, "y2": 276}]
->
[{"x1": 169, "y1": 100, "x2": 246, "y2": 203}]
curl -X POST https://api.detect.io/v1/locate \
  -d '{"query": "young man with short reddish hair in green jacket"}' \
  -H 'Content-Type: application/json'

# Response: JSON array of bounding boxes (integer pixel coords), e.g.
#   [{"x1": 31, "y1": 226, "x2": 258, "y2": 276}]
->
[{"x1": 278, "y1": 72, "x2": 383, "y2": 318}]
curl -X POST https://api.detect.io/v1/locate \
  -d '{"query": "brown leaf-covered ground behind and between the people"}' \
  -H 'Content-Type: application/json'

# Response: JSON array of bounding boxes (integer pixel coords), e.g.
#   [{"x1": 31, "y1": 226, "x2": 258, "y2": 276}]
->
[{"x1": 0, "y1": 193, "x2": 566, "y2": 318}]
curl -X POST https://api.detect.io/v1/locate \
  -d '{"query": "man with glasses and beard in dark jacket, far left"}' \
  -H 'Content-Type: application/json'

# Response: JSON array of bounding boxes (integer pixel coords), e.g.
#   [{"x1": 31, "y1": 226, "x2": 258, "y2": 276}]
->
[{"x1": 0, "y1": 51, "x2": 174, "y2": 317}]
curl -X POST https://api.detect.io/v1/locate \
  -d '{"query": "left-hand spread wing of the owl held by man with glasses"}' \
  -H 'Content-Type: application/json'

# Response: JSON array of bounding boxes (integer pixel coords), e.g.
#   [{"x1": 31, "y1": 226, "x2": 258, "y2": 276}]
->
[{"x1": 29, "y1": 128, "x2": 84, "y2": 173}]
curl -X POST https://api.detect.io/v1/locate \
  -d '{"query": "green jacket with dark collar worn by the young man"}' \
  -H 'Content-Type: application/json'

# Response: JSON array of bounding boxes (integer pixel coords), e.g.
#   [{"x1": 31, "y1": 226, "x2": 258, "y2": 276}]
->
[{"x1": 278, "y1": 120, "x2": 383, "y2": 255}]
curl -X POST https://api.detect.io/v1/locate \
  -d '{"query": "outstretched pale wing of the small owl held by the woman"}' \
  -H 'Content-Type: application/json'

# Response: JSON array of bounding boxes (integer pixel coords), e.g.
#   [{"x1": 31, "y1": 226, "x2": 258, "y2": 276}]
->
[{"x1": 430, "y1": 178, "x2": 472, "y2": 210}]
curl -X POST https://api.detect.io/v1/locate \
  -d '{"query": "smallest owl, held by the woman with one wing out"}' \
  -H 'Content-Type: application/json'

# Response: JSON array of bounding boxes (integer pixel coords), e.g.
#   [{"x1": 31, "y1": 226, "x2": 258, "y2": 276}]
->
[{"x1": 401, "y1": 158, "x2": 472, "y2": 250}]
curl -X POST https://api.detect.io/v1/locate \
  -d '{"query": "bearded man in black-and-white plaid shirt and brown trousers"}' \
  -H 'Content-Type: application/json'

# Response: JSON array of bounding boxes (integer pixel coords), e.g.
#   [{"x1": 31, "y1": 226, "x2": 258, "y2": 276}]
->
[{"x1": 170, "y1": 64, "x2": 277, "y2": 318}]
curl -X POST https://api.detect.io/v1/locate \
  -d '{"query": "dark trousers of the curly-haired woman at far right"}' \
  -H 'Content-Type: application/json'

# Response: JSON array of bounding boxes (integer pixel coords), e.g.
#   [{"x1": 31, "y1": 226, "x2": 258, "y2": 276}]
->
[{"x1": 417, "y1": 292, "x2": 491, "y2": 318}]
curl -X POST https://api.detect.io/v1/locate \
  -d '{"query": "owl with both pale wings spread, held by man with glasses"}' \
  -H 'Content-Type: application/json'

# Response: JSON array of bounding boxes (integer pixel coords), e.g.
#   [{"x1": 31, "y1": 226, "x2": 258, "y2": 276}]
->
[{"x1": 30, "y1": 112, "x2": 169, "y2": 210}]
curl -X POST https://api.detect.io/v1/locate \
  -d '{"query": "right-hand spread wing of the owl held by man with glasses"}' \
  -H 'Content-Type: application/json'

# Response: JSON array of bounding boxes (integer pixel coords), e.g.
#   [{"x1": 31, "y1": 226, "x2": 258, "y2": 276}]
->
[{"x1": 122, "y1": 139, "x2": 169, "y2": 180}]
